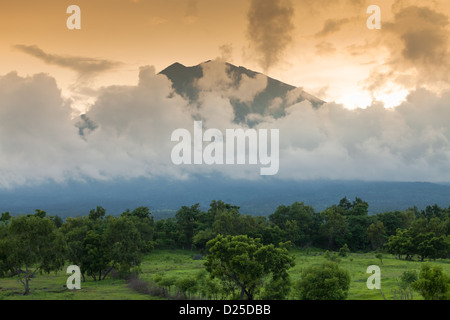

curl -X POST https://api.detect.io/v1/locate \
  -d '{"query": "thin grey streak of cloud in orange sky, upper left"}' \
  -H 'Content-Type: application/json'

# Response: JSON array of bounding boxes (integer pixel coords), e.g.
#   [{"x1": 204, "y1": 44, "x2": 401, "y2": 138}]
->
[{"x1": 14, "y1": 44, "x2": 121, "y2": 78}]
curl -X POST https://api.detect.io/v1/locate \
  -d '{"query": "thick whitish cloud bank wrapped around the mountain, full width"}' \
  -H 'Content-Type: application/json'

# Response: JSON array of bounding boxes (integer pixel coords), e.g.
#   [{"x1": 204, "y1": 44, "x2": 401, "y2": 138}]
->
[{"x1": 0, "y1": 61, "x2": 450, "y2": 188}]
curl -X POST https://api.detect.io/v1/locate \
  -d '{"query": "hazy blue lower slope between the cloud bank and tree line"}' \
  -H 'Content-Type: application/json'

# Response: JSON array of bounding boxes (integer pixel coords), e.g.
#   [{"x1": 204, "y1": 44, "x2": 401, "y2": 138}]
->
[{"x1": 0, "y1": 177, "x2": 450, "y2": 217}]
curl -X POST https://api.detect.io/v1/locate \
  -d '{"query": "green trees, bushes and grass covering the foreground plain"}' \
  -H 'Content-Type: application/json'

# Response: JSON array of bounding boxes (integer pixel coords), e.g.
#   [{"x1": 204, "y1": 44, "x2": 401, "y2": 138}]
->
[{"x1": 0, "y1": 198, "x2": 450, "y2": 300}]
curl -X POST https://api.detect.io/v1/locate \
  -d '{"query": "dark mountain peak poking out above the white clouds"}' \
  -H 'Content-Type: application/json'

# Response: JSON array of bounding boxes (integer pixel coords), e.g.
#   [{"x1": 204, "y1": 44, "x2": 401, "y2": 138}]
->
[{"x1": 160, "y1": 61, "x2": 324, "y2": 123}]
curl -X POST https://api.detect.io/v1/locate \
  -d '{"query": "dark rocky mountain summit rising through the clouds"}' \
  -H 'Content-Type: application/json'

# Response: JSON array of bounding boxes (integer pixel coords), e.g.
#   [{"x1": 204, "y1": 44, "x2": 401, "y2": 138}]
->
[{"x1": 160, "y1": 60, "x2": 324, "y2": 125}]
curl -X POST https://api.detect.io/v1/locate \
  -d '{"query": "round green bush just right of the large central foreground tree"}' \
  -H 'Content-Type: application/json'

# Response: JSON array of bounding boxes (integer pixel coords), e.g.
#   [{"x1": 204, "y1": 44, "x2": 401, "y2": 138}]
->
[{"x1": 296, "y1": 262, "x2": 350, "y2": 300}]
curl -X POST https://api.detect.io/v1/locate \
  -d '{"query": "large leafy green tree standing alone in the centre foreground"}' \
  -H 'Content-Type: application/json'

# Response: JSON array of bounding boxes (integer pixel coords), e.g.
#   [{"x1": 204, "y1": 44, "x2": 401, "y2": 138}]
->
[{"x1": 205, "y1": 235, "x2": 294, "y2": 300}]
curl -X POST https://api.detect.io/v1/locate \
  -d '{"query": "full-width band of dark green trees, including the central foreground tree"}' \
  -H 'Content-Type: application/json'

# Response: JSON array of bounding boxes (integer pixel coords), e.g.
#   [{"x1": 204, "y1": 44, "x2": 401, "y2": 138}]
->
[{"x1": 0, "y1": 198, "x2": 450, "y2": 298}]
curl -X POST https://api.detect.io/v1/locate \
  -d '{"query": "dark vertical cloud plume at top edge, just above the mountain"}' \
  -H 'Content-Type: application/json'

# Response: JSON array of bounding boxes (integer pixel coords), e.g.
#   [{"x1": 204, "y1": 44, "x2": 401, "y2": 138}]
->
[{"x1": 247, "y1": 0, "x2": 294, "y2": 71}]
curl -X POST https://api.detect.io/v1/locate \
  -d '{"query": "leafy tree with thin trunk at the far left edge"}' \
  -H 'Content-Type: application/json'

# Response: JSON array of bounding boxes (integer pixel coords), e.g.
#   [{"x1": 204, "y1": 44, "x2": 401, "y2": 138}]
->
[{"x1": 0, "y1": 215, "x2": 64, "y2": 294}]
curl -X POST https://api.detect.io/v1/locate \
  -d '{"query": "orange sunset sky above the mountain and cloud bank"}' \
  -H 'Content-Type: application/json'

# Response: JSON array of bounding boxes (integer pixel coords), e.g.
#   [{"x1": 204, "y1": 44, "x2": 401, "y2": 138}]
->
[{"x1": 0, "y1": 0, "x2": 450, "y2": 108}]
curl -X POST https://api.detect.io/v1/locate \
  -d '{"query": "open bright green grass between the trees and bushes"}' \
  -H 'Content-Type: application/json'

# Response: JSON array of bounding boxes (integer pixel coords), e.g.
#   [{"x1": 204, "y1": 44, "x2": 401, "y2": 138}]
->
[{"x1": 0, "y1": 250, "x2": 450, "y2": 300}]
